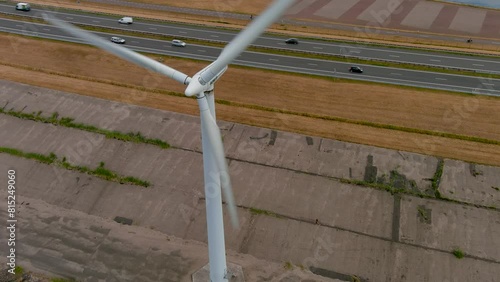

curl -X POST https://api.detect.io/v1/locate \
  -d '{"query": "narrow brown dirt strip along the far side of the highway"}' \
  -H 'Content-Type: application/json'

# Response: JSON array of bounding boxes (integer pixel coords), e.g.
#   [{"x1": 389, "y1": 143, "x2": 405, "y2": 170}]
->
[{"x1": 23, "y1": 0, "x2": 500, "y2": 55}]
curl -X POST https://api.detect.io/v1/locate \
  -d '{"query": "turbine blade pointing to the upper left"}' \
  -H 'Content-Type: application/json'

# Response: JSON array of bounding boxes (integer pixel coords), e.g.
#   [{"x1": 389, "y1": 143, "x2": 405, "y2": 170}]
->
[{"x1": 43, "y1": 14, "x2": 190, "y2": 84}]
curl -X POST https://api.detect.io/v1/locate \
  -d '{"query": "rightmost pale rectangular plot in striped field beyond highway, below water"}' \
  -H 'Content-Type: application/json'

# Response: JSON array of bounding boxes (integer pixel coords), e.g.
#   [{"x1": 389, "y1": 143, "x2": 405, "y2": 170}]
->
[{"x1": 450, "y1": 7, "x2": 487, "y2": 34}]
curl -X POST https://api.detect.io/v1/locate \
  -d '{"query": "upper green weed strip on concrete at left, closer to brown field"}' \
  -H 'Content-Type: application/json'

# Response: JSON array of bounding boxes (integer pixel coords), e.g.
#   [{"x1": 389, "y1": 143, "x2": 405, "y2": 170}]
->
[{"x1": 0, "y1": 105, "x2": 170, "y2": 149}]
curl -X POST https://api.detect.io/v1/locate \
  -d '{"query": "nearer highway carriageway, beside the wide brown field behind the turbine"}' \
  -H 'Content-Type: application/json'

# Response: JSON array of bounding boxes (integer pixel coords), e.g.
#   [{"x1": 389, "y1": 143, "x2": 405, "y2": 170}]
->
[{"x1": 0, "y1": 19, "x2": 500, "y2": 96}]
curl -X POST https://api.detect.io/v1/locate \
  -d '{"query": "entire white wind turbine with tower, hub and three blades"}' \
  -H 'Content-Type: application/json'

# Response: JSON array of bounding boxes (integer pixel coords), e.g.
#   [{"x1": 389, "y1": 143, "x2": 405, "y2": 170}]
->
[{"x1": 44, "y1": 0, "x2": 295, "y2": 282}]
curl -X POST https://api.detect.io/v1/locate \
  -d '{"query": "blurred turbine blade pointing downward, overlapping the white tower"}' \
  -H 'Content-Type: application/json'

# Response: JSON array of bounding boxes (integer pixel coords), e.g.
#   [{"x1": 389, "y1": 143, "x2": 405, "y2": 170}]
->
[{"x1": 200, "y1": 102, "x2": 239, "y2": 228}]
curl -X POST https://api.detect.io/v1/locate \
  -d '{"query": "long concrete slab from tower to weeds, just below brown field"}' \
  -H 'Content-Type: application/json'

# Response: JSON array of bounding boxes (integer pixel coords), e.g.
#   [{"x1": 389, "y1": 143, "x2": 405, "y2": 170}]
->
[{"x1": 224, "y1": 125, "x2": 438, "y2": 191}]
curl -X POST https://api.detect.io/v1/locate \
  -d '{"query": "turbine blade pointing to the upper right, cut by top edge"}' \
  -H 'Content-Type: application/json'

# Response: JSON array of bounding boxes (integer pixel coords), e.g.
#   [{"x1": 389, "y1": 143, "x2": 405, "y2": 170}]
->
[{"x1": 200, "y1": 0, "x2": 295, "y2": 82}]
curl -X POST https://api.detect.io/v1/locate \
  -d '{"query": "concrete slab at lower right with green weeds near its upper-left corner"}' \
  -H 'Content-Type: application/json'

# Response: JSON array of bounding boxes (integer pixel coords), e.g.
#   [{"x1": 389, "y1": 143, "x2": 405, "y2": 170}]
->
[{"x1": 400, "y1": 196, "x2": 500, "y2": 263}]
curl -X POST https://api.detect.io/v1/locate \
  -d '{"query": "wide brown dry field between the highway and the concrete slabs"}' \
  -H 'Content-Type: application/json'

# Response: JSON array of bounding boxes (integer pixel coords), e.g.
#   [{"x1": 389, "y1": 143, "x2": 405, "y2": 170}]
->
[{"x1": 0, "y1": 35, "x2": 500, "y2": 165}]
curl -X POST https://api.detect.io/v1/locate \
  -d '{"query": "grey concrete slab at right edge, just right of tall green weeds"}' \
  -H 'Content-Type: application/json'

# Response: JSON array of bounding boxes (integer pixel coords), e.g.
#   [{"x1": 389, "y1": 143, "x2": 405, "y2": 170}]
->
[{"x1": 439, "y1": 160, "x2": 500, "y2": 208}]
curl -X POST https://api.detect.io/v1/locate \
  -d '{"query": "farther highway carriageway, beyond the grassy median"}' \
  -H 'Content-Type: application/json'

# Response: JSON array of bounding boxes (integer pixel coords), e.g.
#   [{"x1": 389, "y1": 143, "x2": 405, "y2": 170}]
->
[{"x1": 0, "y1": 4, "x2": 500, "y2": 74}]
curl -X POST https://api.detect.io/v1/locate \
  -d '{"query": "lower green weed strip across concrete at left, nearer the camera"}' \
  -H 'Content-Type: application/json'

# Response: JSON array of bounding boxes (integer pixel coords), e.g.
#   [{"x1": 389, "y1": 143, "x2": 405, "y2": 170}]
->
[{"x1": 0, "y1": 147, "x2": 151, "y2": 187}]
